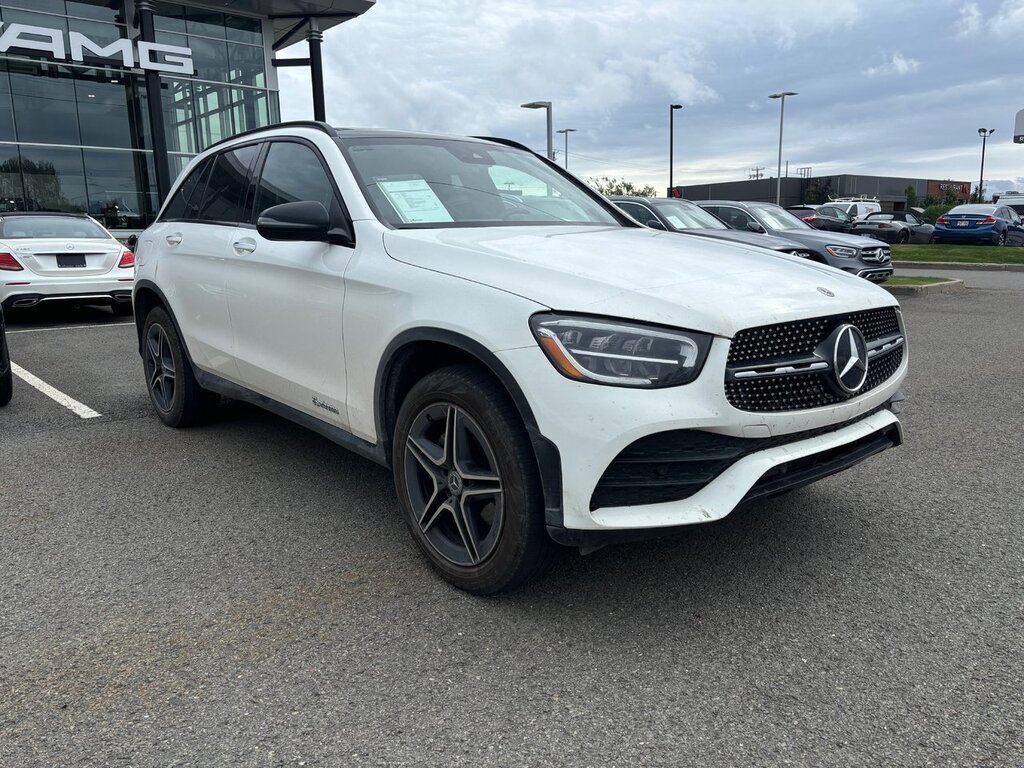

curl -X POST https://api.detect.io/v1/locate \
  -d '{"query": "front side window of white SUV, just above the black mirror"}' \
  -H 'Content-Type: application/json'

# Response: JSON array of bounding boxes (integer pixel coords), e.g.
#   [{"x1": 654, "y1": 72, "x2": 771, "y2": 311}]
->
[{"x1": 254, "y1": 141, "x2": 340, "y2": 217}]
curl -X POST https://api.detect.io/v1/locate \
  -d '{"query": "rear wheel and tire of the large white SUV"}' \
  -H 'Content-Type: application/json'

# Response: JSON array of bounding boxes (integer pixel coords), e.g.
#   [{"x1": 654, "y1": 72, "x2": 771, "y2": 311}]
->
[{"x1": 142, "y1": 307, "x2": 219, "y2": 427}]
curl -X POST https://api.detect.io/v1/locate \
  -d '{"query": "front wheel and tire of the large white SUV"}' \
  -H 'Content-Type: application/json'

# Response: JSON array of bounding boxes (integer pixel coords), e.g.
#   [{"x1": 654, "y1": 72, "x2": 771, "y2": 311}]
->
[{"x1": 391, "y1": 366, "x2": 556, "y2": 595}]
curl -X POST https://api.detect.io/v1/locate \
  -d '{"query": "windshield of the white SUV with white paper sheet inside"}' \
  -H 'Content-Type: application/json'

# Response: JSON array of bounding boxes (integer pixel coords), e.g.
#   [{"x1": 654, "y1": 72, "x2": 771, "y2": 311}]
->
[{"x1": 339, "y1": 136, "x2": 622, "y2": 228}]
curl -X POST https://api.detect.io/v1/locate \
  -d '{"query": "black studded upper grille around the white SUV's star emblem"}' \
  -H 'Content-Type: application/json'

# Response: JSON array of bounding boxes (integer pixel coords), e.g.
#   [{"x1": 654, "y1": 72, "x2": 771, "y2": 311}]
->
[{"x1": 725, "y1": 307, "x2": 904, "y2": 413}]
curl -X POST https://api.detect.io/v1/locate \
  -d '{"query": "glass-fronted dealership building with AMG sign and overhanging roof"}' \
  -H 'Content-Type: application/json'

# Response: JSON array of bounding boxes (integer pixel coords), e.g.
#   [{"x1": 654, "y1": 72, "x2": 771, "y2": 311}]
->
[{"x1": 0, "y1": 0, "x2": 374, "y2": 230}]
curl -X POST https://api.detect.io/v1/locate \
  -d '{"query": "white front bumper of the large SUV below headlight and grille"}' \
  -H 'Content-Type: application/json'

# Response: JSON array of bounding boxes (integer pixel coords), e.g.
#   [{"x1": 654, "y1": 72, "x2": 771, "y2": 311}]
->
[{"x1": 499, "y1": 339, "x2": 908, "y2": 543}]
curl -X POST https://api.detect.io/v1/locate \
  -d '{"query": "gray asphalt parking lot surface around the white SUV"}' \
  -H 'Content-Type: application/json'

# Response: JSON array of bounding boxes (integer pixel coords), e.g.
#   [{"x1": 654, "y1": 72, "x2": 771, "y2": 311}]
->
[{"x1": 0, "y1": 288, "x2": 1024, "y2": 766}]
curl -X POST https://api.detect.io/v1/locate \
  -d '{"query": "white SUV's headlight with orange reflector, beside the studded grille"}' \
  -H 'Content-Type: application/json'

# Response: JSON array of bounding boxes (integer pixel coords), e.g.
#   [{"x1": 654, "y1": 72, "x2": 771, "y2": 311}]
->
[{"x1": 529, "y1": 314, "x2": 712, "y2": 389}]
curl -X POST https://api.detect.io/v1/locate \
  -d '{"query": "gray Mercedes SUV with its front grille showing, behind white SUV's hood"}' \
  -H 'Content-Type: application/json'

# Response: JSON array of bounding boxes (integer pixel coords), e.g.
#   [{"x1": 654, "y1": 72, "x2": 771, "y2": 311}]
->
[{"x1": 696, "y1": 200, "x2": 893, "y2": 283}]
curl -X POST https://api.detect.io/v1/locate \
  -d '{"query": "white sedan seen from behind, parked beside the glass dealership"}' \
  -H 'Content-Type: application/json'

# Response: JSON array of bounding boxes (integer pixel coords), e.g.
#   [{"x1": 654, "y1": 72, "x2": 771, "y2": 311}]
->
[{"x1": 0, "y1": 212, "x2": 135, "y2": 314}]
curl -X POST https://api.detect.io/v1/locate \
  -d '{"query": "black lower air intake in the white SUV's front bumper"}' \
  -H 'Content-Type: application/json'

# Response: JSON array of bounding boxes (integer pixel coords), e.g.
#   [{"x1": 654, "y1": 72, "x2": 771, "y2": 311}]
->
[{"x1": 590, "y1": 407, "x2": 885, "y2": 510}]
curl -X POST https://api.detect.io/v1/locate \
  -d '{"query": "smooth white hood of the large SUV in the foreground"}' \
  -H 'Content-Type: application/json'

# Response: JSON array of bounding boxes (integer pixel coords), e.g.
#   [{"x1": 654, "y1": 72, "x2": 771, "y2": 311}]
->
[{"x1": 384, "y1": 226, "x2": 896, "y2": 337}]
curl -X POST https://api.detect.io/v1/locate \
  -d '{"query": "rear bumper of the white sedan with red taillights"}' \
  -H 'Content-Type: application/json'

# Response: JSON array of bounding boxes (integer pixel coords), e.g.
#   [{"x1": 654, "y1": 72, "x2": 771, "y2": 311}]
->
[{"x1": 0, "y1": 269, "x2": 135, "y2": 309}]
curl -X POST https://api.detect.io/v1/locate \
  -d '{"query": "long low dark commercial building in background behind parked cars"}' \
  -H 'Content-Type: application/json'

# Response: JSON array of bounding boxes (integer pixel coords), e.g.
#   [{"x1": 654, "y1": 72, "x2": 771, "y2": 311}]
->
[{"x1": 669, "y1": 174, "x2": 973, "y2": 211}]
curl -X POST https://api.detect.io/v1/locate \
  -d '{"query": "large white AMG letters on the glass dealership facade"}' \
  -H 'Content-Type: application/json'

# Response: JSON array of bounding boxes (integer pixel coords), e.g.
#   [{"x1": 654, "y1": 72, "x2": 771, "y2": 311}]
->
[{"x1": 0, "y1": 24, "x2": 196, "y2": 75}]
